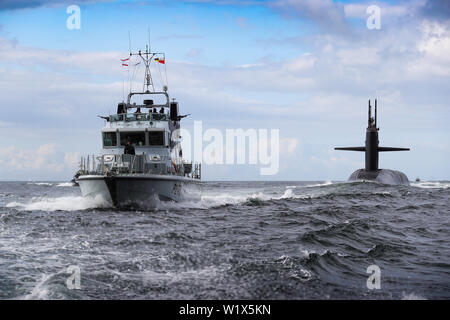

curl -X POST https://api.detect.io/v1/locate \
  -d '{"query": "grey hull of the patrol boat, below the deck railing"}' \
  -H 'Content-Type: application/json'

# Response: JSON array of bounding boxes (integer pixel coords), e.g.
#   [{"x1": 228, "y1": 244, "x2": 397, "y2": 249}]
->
[{"x1": 77, "y1": 174, "x2": 201, "y2": 208}]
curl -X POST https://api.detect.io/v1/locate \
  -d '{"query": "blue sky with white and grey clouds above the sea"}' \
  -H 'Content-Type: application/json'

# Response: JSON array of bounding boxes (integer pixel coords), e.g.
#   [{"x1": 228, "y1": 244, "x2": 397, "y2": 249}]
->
[{"x1": 0, "y1": 0, "x2": 450, "y2": 181}]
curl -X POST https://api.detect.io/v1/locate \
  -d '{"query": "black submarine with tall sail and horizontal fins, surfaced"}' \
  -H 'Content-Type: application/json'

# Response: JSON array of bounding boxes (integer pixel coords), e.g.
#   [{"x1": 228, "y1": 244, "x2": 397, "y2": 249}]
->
[{"x1": 334, "y1": 99, "x2": 409, "y2": 185}]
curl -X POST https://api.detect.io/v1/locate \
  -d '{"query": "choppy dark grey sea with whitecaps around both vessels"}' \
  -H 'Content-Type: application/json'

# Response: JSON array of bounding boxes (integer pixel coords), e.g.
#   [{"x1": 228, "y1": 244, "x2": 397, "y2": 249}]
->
[{"x1": 0, "y1": 181, "x2": 450, "y2": 300}]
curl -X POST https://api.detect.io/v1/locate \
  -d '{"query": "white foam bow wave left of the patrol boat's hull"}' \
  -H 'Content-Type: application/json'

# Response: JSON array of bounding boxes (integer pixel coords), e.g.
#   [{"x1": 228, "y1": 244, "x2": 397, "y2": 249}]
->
[{"x1": 6, "y1": 195, "x2": 111, "y2": 211}]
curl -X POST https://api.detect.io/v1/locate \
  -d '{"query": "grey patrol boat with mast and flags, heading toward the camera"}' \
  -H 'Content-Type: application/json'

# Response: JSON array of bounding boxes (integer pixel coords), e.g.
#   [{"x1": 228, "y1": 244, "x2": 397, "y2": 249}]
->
[{"x1": 75, "y1": 46, "x2": 201, "y2": 207}]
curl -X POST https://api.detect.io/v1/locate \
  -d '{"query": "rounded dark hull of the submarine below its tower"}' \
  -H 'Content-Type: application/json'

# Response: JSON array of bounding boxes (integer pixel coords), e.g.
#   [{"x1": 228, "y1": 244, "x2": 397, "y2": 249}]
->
[{"x1": 348, "y1": 169, "x2": 409, "y2": 186}]
